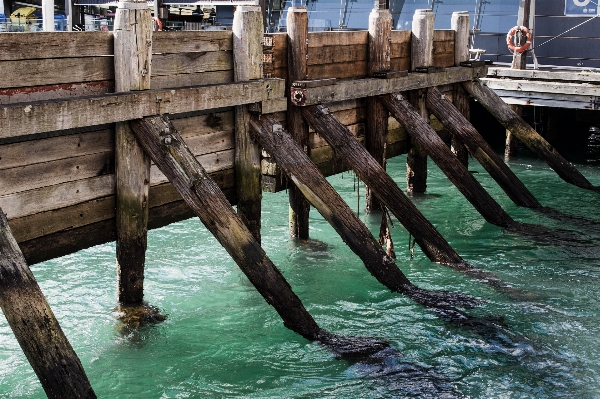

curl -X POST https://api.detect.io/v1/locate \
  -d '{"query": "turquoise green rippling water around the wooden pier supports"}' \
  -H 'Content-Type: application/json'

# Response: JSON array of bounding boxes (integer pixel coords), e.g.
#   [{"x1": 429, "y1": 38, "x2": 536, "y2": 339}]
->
[{"x1": 0, "y1": 152, "x2": 600, "y2": 399}]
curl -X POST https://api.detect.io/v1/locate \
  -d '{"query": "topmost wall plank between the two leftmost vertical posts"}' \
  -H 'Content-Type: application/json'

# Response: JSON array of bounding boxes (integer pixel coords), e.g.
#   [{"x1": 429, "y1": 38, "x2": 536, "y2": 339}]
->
[{"x1": 152, "y1": 30, "x2": 233, "y2": 54}]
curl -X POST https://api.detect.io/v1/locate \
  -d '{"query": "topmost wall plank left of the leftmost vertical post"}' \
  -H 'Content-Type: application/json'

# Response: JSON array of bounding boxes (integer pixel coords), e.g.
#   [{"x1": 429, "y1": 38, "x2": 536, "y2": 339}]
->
[{"x1": 0, "y1": 32, "x2": 114, "y2": 61}]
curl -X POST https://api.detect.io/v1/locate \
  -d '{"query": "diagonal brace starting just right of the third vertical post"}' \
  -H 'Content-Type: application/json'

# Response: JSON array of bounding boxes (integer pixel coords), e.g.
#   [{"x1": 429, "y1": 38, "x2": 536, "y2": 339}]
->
[{"x1": 302, "y1": 105, "x2": 470, "y2": 270}]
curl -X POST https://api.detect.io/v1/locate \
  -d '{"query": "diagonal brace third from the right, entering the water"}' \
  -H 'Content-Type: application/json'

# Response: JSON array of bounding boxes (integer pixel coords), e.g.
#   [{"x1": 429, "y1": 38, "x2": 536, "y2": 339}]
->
[{"x1": 381, "y1": 94, "x2": 513, "y2": 227}]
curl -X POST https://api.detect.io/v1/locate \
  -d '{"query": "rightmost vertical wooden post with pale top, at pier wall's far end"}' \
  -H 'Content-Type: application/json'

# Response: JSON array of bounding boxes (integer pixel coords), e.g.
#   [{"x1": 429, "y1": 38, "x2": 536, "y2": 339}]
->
[{"x1": 450, "y1": 11, "x2": 470, "y2": 166}]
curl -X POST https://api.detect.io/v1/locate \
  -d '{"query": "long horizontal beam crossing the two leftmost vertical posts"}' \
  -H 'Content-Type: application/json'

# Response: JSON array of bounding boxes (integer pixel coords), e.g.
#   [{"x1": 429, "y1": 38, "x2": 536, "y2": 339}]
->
[{"x1": 0, "y1": 79, "x2": 285, "y2": 138}]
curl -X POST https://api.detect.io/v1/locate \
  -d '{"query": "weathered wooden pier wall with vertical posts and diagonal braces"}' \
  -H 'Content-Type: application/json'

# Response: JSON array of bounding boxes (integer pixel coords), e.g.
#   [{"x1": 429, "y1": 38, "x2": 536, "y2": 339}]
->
[{"x1": 0, "y1": 1, "x2": 595, "y2": 398}]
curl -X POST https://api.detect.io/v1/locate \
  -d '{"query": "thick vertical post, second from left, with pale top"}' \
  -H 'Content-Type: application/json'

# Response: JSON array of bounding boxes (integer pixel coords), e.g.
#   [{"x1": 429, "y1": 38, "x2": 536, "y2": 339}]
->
[{"x1": 232, "y1": 6, "x2": 263, "y2": 243}]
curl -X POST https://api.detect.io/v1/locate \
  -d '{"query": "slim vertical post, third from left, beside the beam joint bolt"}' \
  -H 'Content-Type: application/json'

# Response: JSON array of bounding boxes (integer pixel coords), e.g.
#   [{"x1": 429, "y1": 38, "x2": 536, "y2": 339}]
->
[{"x1": 286, "y1": 7, "x2": 310, "y2": 239}]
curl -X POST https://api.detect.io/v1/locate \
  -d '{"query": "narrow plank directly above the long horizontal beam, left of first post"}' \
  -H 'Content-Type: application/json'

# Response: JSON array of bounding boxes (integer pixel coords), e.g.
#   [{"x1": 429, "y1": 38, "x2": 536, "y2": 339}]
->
[{"x1": 0, "y1": 80, "x2": 115, "y2": 104}]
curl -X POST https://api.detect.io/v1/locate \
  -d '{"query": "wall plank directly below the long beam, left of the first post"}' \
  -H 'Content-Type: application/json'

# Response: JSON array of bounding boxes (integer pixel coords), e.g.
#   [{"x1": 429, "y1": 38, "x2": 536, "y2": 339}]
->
[{"x1": 0, "y1": 129, "x2": 115, "y2": 170}]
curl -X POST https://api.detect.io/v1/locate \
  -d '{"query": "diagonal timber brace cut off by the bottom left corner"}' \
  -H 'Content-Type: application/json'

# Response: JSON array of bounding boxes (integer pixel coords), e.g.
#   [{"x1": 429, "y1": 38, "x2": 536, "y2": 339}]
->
[{"x1": 0, "y1": 209, "x2": 96, "y2": 399}]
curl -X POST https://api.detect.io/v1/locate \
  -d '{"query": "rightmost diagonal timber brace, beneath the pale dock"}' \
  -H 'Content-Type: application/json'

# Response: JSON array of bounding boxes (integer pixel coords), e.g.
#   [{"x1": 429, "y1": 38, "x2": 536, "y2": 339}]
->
[{"x1": 463, "y1": 82, "x2": 594, "y2": 189}]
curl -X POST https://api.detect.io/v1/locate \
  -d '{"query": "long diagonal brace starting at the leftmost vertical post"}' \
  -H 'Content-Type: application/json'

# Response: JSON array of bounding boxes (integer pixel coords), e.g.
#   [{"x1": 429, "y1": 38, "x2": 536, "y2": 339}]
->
[{"x1": 131, "y1": 117, "x2": 321, "y2": 339}]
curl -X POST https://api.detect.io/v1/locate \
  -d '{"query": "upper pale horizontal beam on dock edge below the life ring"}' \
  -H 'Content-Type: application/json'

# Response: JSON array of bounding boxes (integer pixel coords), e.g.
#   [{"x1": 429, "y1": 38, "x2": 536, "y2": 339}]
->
[{"x1": 480, "y1": 78, "x2": 600, "y2": 97}]
